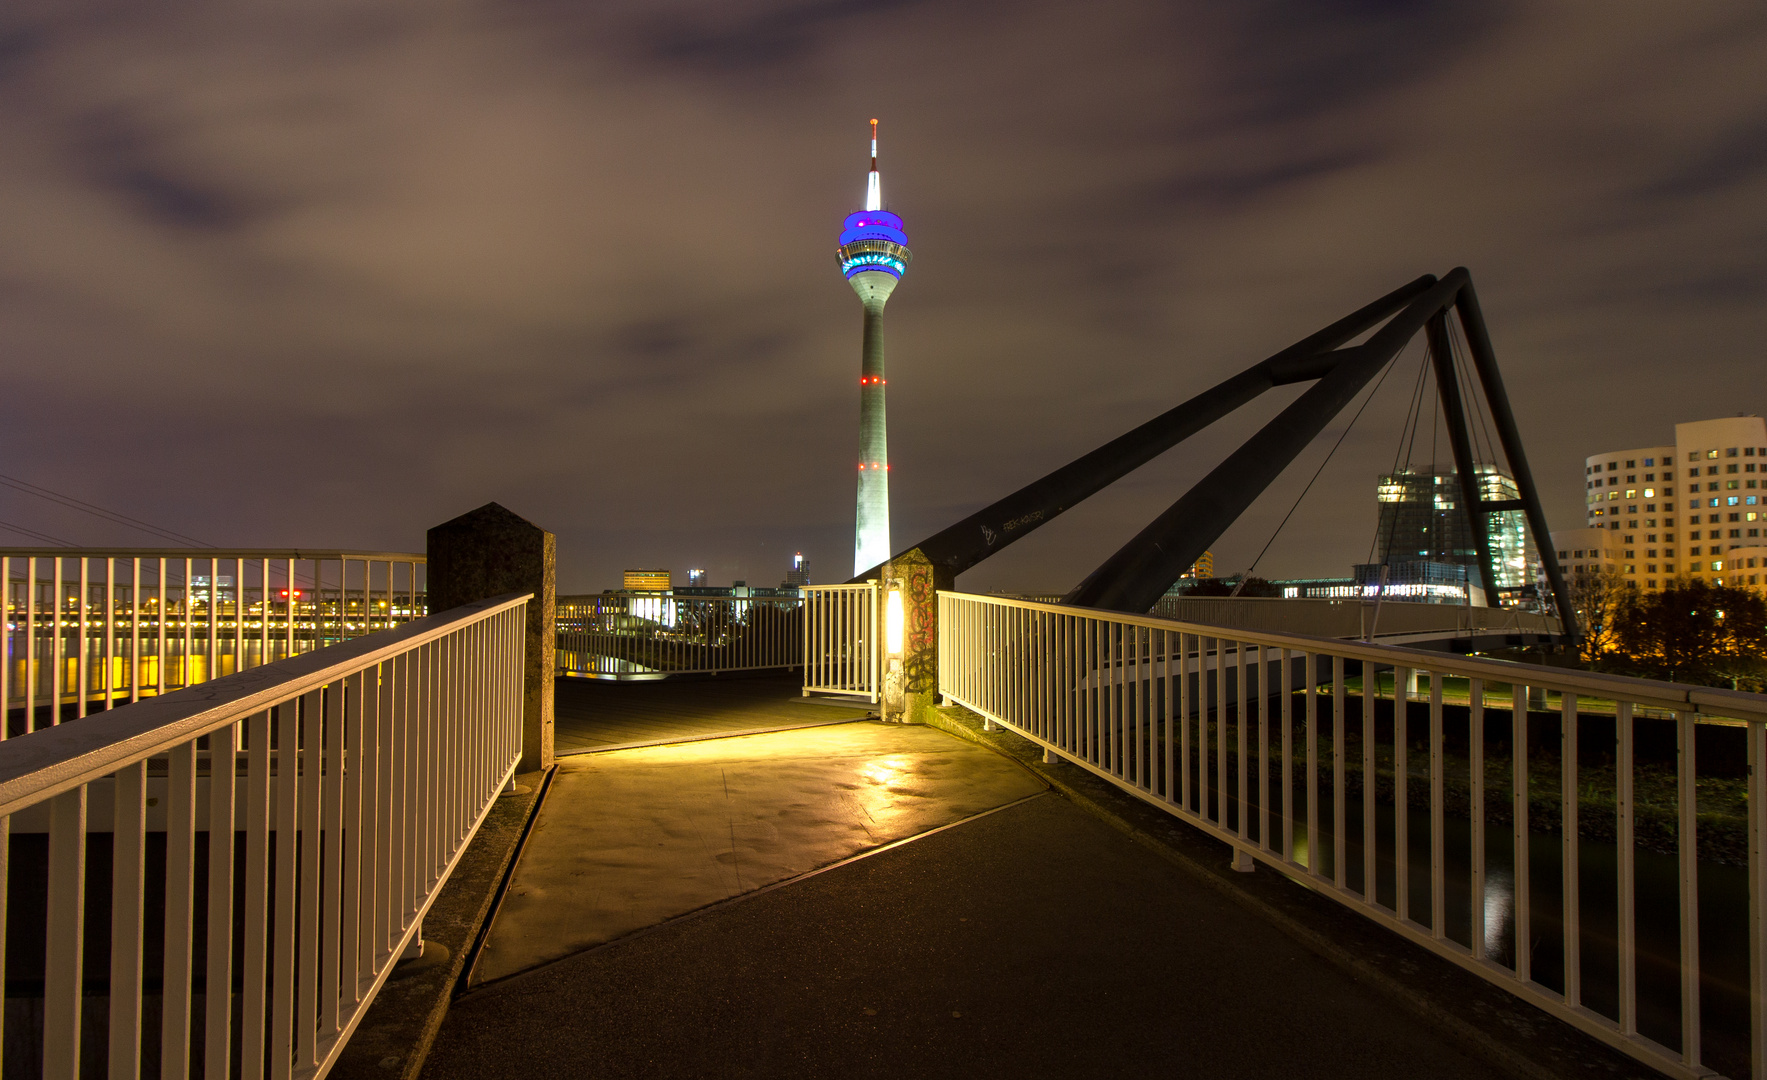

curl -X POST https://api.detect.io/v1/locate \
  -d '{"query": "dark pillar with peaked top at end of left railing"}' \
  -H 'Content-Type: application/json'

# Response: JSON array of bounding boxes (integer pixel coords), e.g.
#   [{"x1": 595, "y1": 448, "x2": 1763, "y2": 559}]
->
[{"x1": 429, "y1": 502, "x2": 558, "y2": 772}]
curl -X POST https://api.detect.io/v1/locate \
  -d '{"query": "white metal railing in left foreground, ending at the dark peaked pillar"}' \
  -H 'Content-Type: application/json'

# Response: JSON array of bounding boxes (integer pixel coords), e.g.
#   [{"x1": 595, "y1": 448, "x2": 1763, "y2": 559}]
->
[{"x1": 0, "y1": 596, "x2": 530, "y2": 1080}]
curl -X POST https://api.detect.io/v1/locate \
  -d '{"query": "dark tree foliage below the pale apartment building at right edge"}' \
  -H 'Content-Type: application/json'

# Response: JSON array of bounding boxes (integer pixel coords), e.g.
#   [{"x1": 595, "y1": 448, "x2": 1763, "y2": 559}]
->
[{"x1": 1613, "y1": 580, "x2": 1767, "y2": 689}]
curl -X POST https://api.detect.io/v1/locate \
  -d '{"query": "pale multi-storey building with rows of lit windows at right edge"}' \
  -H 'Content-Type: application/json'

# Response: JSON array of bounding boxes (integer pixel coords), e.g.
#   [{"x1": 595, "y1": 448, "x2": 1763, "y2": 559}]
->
[{"x1": 1576, "y1": 415, "x2": 1767, "y2": 592}]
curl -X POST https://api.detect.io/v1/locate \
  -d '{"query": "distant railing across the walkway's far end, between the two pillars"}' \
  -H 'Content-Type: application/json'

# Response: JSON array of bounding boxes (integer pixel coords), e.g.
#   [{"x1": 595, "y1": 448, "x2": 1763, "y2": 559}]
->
[{"x1": 557, "y1": 590, "x2": 802, "y2": 679}]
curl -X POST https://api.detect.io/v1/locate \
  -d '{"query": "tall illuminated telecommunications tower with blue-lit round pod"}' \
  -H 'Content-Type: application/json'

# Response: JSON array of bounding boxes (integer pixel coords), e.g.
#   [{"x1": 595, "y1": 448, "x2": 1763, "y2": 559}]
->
[{"x1": 839, "y1": 120, "x2": 910, "y2": 574}]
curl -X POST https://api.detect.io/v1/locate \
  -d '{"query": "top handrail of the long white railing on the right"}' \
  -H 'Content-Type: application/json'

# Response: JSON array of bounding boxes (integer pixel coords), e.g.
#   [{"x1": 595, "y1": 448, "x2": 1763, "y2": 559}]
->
[{"x1": 945, "y1": 590, "x2": 1767, "y2": 721}]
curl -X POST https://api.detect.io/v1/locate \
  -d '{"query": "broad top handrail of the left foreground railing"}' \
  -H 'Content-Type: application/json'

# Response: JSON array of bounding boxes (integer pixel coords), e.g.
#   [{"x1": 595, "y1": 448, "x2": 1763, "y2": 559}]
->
[{"x1": 0, "y1": 592, "x2": 534, "y2": 817}]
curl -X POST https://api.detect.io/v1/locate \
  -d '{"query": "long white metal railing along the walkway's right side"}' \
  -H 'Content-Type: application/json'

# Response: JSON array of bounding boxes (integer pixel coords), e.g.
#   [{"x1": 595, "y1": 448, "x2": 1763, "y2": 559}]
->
[{"x1": 938, "y1": 592, "x2": 1767, "y2": 1078}]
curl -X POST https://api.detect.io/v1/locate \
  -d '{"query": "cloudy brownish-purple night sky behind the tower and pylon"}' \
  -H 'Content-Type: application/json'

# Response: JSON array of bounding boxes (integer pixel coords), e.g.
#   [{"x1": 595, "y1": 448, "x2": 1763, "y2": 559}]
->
[{"x1": 0, "y1": 0, "x2": 1767, "y2": 592}]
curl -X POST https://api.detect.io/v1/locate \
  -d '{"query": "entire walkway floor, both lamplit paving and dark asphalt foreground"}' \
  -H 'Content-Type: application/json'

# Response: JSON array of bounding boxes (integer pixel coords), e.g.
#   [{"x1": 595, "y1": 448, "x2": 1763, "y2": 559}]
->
[{"x1": 424, "y1": 710, "x2": 1504, "y2": 1080}]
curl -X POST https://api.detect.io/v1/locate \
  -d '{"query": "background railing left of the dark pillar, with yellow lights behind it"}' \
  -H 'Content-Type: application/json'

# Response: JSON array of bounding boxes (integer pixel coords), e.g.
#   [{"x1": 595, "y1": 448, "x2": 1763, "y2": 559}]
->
[{"x1": 0, "y1": 548, "x2": 426, "y2": 734}]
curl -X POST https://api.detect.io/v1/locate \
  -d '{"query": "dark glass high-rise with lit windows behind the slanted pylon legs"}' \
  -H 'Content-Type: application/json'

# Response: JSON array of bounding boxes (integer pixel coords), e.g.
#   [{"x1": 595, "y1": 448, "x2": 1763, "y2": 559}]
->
[{"x1": 1355, "y1": 465, "x2": 1543, "y2": 605}]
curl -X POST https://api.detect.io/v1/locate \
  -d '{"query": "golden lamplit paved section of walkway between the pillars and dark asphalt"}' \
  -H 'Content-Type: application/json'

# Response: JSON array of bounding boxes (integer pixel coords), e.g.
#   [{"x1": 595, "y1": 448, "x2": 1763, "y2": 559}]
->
[{"x1": 472, "y1": 721, "x2": 1046, "y2": 985}]
